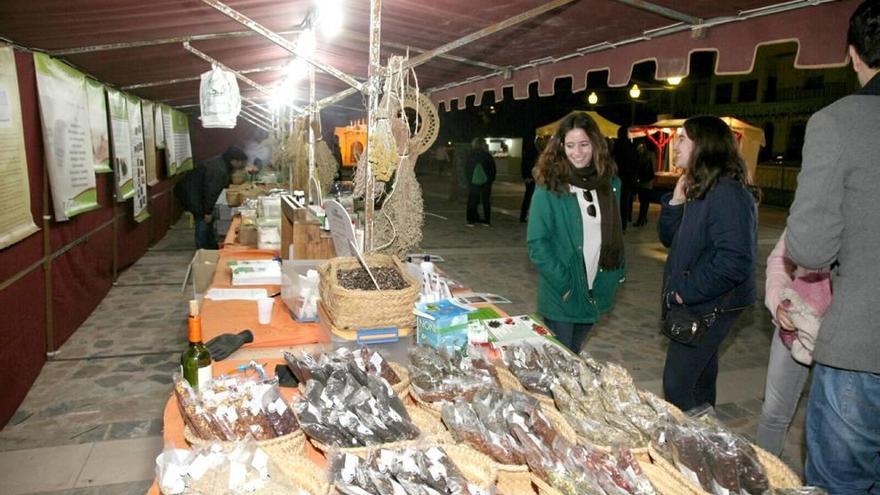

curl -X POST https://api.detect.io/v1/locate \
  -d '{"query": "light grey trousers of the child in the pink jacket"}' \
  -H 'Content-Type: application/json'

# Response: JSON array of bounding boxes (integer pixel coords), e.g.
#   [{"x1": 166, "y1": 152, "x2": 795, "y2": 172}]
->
[{"x1": 756, "y1": 328, "x2": 810, "y2": 456}]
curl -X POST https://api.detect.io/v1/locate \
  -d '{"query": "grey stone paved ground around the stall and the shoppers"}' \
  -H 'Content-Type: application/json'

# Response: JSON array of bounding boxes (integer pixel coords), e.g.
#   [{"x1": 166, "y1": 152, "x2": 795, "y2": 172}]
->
[{"x1": 0, "y1": 176, "x2": 803, "y2": 495}]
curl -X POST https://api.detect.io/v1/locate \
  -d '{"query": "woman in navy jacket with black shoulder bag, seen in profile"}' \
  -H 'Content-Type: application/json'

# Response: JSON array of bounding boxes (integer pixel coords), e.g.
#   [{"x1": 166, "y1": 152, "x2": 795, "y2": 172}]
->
[{"x1": 657, "y1": 116, "x2": 757, "y2": 413}]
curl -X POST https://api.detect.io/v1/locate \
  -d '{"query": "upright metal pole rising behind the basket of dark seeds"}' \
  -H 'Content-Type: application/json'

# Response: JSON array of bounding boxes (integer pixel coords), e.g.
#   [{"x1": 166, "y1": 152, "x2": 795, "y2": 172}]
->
[{"x1": 363, "y1": 0, "x2": 382, "y2": 253}]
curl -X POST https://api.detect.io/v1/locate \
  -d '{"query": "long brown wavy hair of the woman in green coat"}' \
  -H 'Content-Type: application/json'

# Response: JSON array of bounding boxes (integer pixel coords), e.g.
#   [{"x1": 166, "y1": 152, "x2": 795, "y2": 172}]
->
[{"x1": 533, "y1": 113, "x2": 614, "y2": 193}]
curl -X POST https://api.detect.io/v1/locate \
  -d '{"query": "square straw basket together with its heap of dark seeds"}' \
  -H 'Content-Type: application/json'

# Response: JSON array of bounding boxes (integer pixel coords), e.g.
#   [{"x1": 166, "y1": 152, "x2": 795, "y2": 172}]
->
[{"x1": 318, "y1": 254, "x2": 419, "y2": 330}]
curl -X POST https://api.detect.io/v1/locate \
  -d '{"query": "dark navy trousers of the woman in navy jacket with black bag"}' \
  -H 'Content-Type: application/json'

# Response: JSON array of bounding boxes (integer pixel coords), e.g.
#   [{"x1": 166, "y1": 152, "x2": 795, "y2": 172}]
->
[{"x1": 663, "y1": 309, "x2": 743, "y2": 412}]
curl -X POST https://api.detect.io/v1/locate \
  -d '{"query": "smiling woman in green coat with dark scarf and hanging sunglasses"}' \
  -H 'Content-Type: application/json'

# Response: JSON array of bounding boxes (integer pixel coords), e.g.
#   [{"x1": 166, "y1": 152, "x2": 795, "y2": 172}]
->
[{"x1": 527, "y1": 114, "x2": 624, "y2": 352}]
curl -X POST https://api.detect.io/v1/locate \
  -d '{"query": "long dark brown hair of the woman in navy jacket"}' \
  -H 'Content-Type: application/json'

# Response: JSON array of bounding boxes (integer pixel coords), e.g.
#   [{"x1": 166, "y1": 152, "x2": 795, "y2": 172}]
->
[{"x1": 684, "y1": 115, "x2": 761, "y2": 200}]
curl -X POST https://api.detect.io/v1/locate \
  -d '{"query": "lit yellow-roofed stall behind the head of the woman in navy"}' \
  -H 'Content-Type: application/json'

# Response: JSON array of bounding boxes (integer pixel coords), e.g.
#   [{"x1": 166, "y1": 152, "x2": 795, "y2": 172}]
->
[{"x1": 629, "y1": 117, "x2": 767, "y2": 186}]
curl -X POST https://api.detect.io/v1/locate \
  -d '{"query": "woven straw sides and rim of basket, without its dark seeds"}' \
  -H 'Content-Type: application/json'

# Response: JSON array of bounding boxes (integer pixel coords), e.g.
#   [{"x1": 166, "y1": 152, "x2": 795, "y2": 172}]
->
[{"x1": 318, "y1": 254, "x2": 419, "y2": 330}]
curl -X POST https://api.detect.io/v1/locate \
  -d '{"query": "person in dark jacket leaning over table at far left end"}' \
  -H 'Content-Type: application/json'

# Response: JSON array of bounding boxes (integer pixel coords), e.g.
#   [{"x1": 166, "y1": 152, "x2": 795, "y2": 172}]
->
[{"x1": 174, "y1": 146, "x2": 247, "y2": 249}]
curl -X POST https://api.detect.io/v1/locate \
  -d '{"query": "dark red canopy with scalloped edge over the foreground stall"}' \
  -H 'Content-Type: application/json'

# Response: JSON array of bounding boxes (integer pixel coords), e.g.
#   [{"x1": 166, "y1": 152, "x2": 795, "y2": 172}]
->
[{"x1": 0, "y1": 0, "x2": 860, "y2": 122}]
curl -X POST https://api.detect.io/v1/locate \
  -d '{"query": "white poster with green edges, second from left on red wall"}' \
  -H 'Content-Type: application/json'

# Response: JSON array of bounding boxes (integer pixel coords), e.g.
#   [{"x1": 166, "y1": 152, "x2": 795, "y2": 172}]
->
[{"x1": 34, "y1": 53, "x2": 98, "y2": 221}]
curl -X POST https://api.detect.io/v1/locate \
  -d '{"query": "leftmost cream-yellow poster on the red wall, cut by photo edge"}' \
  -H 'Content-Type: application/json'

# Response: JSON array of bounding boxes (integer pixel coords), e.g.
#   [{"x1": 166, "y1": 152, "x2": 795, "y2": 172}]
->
[{"x1": 0, "y1": 46, "x2": 40, "y2": 249}]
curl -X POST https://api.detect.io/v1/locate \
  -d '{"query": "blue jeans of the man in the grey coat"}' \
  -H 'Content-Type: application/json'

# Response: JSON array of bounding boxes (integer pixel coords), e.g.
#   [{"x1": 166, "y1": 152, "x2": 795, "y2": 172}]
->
[{"x1": 804, "y1": 363, "x2": 880, "y2": 495}]
